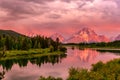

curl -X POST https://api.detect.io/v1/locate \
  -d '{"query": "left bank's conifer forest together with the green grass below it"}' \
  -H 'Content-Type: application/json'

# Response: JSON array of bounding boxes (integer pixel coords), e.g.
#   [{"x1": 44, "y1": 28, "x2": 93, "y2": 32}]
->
[{"x1": 0, "y1": 33, "x2": 66, "y2": 60}]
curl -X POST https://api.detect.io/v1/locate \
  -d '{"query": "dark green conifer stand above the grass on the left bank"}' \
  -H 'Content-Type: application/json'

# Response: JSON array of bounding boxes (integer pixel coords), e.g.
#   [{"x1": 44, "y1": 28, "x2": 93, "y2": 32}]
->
[{"x1": 0, "y1": 35, "x2": 63, "y2": 52}]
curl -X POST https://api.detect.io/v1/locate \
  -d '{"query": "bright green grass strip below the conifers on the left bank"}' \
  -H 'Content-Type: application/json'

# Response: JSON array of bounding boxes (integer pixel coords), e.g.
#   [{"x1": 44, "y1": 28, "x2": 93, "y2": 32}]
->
[{"x1": 0, "y1": 48, "x2": 64, "y2": 60}]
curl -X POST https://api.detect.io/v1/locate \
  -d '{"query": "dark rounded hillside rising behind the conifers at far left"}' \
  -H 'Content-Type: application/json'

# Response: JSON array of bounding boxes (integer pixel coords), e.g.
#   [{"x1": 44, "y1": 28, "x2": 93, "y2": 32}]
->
[{"x1": 0, "y1": 30, "x2": 25, "y2": 37}]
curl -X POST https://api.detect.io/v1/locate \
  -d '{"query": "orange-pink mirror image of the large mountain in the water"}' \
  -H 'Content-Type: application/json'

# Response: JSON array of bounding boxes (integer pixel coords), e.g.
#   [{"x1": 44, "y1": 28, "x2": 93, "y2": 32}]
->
[{"x1": 73, "y1": 49, "x2": 99, "y2": 62}]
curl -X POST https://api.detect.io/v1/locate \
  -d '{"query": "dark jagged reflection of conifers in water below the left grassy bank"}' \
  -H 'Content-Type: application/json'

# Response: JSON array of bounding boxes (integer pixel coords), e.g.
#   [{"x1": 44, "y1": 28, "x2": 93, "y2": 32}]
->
[{"x1": 0, "y1": 54, "x2": 66, "y2": 71}]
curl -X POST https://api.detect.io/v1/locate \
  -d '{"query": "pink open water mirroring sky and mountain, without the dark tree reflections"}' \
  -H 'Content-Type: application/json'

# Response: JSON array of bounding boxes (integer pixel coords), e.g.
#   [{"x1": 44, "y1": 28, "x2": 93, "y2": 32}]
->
[{"x1": 1, "y1": 48, "x2": 120, "y2": 80}]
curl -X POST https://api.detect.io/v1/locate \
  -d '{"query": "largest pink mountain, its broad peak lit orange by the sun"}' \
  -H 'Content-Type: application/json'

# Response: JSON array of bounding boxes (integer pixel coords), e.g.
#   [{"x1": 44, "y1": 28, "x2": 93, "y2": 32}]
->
[{"x1": 66, "y1": 28, "x2": 109, "y2": 43}]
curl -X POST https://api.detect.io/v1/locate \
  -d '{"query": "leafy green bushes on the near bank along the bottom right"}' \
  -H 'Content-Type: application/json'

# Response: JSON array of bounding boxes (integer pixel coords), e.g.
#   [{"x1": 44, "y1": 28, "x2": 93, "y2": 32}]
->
[{"x1": 39, "y1": 59, "x2": 120, "y2": 80}]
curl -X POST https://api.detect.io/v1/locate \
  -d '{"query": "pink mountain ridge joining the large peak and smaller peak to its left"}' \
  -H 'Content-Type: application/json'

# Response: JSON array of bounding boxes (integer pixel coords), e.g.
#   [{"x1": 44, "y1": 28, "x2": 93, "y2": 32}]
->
[{"x1": 51, "y1": 27, "x2": 110, "y2": 43}]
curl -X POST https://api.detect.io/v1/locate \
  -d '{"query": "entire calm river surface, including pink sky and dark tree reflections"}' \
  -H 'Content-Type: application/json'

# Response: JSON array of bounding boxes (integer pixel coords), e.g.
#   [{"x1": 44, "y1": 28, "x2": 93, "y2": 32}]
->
[{"x1": 0, "y1": 47, "x2": 120, "y2": 80}]
